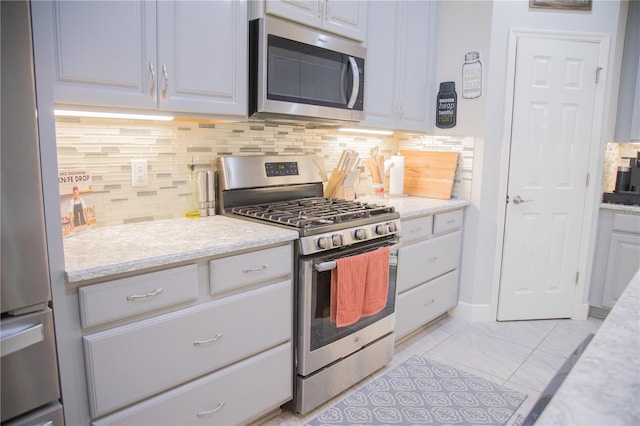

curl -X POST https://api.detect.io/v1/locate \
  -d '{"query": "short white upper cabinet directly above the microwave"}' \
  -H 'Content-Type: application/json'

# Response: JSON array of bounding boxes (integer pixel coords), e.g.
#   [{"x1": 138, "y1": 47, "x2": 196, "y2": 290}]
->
[{"x1": 265, "y1": 0, "x2": 369, "y2": 41}]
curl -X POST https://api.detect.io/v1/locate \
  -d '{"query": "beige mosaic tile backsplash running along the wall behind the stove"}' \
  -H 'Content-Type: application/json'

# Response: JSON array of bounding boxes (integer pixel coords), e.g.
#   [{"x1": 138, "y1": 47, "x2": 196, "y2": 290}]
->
[{"x1": 56, "y1": 117, "x2": 474, "y2": 226}]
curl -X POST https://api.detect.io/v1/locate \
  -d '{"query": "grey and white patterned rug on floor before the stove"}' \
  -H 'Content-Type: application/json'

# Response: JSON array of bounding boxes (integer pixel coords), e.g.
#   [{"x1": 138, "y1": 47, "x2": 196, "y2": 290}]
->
[{"x1": 308, "y1": 355, "x2": 527, "y2": 426}]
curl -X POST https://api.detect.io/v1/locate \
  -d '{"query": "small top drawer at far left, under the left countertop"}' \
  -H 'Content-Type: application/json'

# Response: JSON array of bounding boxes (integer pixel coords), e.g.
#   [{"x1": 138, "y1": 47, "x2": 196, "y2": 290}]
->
[{"x1": 78, "y1": 265, "x2": 198, "y2": 328}]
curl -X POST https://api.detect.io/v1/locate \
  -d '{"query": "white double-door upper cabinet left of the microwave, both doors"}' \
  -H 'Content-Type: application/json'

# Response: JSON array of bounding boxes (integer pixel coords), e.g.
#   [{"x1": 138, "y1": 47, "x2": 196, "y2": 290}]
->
[{"x1": 33, "y1": 0, "x2": 247, "y2": 115}]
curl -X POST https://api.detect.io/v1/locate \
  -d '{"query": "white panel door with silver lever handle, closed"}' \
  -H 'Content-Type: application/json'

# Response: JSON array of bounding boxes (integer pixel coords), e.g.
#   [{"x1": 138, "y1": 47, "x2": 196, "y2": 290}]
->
[{"x1": 498, "y1": 37, "x2": 599, "y2": 320}]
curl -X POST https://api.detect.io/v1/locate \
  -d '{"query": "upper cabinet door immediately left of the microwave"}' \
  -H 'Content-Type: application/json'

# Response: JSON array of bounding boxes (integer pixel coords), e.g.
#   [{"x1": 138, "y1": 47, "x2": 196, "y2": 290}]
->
[{"x1": 157, "y1": 0, "x2": 248, "y2": 115}]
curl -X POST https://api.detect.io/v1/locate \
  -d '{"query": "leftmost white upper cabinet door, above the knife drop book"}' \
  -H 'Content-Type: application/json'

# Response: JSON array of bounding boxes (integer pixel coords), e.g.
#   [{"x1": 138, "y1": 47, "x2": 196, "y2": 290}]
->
[{"x1": 32, "y1": 0, "x2": 157, "y2": 109}]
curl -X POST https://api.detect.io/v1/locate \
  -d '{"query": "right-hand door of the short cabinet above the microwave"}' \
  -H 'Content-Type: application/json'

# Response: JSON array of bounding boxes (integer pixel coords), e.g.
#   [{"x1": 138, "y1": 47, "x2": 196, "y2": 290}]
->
[{"x1": 322, "y1": 0, "x2": 368, "y2": 41}]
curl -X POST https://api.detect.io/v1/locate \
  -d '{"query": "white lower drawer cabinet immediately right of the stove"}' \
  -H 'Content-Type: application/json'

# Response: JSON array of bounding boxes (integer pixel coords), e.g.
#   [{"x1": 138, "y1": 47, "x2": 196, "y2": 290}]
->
[{"x1": 396, "y1": 209, "x2": 463, "y2": 339}]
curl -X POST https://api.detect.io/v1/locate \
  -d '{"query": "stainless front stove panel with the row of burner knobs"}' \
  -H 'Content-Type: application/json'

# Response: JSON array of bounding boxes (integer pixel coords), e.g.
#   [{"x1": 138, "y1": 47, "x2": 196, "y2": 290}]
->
[{"x1": 300, "y1": 219, "x2": 400, "y2": 255}]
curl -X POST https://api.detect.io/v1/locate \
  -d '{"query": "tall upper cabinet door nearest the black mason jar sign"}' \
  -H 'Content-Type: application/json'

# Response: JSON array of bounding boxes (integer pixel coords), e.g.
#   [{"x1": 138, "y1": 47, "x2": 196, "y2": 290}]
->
[{"x1": 395, "y1": 1, "x2": 437, "y2": 131}]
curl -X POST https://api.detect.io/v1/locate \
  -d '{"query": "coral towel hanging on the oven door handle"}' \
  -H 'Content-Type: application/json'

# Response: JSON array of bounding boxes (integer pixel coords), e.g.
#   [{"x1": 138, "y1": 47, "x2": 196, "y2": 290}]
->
[{"x1": 330, "y1": 247, "x2": 390, "y2": 327}]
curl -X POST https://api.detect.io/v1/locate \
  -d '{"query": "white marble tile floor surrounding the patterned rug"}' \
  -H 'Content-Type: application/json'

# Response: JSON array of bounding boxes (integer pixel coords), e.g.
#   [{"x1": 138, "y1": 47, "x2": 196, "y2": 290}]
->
[{"x1": 256, "y1": 317, "x2": 602, "y2": 426}]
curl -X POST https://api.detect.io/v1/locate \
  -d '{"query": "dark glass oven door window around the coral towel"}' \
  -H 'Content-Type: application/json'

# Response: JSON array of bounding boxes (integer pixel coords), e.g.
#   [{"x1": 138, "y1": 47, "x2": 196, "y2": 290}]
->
[{"x1": 309, "y1": 241, "x2": 398, "y2": 351}]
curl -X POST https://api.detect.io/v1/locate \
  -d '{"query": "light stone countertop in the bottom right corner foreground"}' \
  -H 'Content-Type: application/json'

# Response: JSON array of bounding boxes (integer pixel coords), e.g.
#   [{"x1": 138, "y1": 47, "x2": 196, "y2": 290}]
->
[{"x1": 536, "y1": 271, "x2": 640, "y2": 426}]
